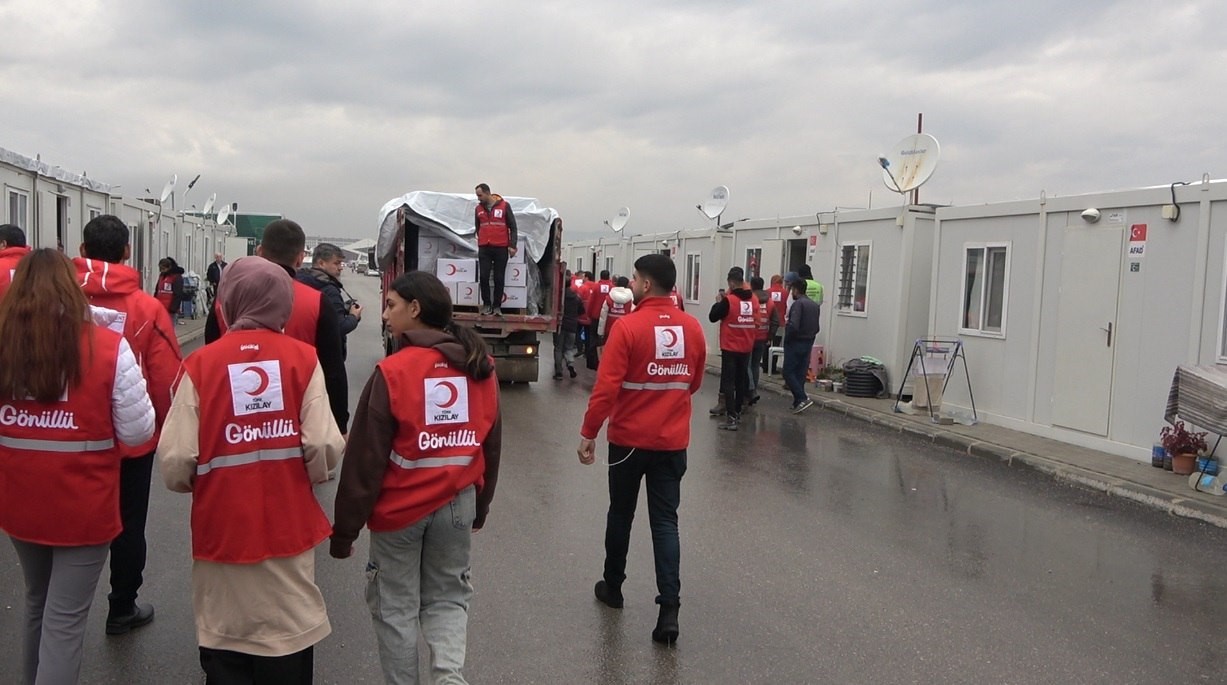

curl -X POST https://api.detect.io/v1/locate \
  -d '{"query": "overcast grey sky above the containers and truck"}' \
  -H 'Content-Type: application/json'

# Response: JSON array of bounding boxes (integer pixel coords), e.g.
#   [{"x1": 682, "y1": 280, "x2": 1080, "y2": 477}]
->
[{"x1": 0, "y1": 0, "x2": 1227, "y2": 243}]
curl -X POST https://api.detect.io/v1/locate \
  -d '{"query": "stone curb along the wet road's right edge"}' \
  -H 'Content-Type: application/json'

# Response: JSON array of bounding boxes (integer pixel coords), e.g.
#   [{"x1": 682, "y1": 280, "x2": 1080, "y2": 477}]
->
[{"x1": 707, "y1": 366, "x2": 1227, "y2": 529}]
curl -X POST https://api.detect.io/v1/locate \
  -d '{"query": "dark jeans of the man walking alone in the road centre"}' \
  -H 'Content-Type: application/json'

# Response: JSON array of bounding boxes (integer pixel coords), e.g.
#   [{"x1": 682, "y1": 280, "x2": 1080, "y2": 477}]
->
[{"x1": 604, "y1": 443, "x2": 686, "y2": 605}]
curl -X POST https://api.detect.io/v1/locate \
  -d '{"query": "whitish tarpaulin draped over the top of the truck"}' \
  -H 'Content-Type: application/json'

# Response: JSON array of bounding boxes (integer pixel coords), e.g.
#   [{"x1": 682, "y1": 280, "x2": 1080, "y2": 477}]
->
[{"x1": 375, "y1": 190, "x2": 558, "y2": 269}]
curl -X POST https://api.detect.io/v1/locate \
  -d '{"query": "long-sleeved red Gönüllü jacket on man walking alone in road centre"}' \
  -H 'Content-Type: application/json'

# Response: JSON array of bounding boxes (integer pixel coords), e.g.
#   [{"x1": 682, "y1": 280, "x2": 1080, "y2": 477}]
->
[{"x1": 579, "y1": 297, "x2": 707, "y2": 451}]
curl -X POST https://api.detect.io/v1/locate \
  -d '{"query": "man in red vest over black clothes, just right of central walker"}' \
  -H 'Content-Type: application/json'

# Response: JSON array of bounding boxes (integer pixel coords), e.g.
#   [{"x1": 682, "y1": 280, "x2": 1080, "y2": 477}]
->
[{"x1": 708, "y1": 266, "x2": 758, "y2": 431}]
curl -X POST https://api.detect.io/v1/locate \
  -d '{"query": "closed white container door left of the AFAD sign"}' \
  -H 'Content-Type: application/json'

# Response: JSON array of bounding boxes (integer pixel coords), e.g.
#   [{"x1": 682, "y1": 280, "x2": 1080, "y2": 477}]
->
[{"x1": 1053, "y1": 226, "x2": 1123, "y2": 436}]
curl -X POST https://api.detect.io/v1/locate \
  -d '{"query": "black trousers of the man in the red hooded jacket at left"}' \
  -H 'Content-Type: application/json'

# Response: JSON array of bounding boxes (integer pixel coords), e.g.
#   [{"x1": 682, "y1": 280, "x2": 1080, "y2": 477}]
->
[{"x1": 107, "y1": 452, "x2": 153, "y2": 616}]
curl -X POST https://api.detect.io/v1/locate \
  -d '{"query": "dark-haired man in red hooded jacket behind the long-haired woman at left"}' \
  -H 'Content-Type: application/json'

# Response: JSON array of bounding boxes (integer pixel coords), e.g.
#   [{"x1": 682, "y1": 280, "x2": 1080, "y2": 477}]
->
[{"x1": 72, "y1": 214, "x2": 182, "y2": 635}]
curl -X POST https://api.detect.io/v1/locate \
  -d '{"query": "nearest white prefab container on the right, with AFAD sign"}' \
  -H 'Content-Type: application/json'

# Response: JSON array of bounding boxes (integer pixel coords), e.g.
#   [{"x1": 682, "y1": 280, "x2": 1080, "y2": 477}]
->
[{"x1": 929, "y1": 180, "x2": 1227, "y2": 459}]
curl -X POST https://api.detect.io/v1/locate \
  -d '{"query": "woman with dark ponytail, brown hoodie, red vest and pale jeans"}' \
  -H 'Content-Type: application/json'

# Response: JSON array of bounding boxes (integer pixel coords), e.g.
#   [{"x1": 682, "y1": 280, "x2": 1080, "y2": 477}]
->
[{"x1": 331, "y1": 271, "x2": 502, "y2": 683}]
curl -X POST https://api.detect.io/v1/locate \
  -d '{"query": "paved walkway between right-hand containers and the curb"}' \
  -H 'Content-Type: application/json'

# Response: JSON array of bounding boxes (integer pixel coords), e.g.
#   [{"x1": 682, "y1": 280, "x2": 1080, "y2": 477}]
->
[{"x1": 708, "y1": 367, "x2": 1227, "y2": 528}]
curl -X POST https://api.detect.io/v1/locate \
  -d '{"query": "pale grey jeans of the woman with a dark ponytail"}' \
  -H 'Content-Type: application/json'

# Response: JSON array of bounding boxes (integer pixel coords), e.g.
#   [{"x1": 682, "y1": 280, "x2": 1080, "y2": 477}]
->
[{"x1": 367, "y1": 485, "x2": 477, "y2": 685}]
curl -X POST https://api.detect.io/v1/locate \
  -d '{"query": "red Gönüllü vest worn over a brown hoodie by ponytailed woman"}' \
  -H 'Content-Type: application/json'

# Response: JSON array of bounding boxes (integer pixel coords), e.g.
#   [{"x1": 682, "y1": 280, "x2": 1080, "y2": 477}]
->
[{"x1": 367, "y1": 346, "x2": 498, "y2": 533}]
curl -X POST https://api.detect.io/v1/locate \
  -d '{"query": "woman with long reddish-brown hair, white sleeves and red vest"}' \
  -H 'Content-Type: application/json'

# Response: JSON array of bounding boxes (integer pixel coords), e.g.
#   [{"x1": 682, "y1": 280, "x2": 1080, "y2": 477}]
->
[{"x1": 0, "y1": 248, "x2": 153, "y2": 683}]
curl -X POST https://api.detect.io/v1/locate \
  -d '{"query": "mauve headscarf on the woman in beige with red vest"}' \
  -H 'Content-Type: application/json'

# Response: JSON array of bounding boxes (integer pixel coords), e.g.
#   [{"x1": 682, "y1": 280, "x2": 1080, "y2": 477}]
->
[{"x1": 217, "y1": 257, "x2": 294, "y2": 330}]
